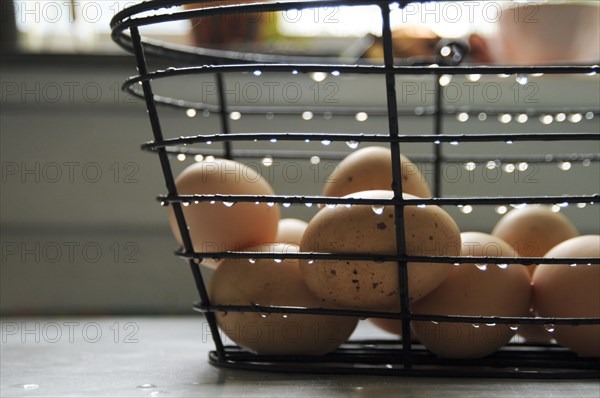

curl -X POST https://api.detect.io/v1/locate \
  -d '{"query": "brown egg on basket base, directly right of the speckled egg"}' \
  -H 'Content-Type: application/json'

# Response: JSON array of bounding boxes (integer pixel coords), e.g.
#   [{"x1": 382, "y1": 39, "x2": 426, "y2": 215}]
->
[{"x1": 411, "y1": 232, "x2": 531, "y2": 358}]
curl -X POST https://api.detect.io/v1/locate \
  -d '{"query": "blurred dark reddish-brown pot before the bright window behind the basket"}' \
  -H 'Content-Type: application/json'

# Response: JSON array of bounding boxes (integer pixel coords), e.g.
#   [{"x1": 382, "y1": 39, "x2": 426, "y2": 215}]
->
[{"x1": 184, "y1": 0, "x2": 274, "y2": 48}]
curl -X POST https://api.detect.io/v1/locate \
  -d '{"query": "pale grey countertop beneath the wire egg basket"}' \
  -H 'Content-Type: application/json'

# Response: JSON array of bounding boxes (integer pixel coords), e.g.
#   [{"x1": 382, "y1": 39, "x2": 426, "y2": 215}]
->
[{"x1": 0, "y1": 315, "x2": 600, "y2": 398}]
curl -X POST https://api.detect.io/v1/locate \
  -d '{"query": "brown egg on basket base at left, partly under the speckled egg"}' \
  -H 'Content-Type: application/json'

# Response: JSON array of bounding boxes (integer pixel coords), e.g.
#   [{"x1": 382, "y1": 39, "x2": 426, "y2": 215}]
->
[{"x1": 208, "y1": 244, "x2": 358, "y2": 356}]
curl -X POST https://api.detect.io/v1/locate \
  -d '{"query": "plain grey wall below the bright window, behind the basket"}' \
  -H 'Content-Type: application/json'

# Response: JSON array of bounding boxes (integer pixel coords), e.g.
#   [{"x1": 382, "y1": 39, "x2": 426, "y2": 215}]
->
[{"x1": 0, "y1": 57, "x2": 600, "y2": 314}]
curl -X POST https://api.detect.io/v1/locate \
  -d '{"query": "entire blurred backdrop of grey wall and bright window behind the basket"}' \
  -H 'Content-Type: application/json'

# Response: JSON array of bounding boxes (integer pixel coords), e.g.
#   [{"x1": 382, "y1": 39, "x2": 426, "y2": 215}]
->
[{"x1": 0, "y1": 0, "x2": 600, "y2": 315}]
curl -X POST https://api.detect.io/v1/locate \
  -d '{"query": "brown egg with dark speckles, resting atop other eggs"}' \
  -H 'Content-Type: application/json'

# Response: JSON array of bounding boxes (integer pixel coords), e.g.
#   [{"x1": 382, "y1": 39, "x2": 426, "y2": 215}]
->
[{"x1": 300, "y1": 190, "x2": 460, "y2": 310}]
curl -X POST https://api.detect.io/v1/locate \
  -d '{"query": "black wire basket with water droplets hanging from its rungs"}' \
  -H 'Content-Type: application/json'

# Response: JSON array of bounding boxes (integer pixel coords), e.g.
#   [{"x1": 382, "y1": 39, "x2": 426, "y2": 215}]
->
[{"x1": 111, "y1": 0, "x2": 600, "y2": 379}]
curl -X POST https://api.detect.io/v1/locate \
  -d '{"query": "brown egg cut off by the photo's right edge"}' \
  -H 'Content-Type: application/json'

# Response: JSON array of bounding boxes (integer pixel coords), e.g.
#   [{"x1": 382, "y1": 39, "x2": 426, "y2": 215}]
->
[{"x1": 532, "y1": 235, "x2": 600, "y2": 357}]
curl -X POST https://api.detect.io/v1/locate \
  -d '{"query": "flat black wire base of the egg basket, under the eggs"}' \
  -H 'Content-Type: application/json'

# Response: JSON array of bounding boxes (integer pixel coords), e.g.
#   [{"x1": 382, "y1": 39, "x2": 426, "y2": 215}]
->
[{"x1": 209, "y1": 340, "x2": 600, "y2": 380}]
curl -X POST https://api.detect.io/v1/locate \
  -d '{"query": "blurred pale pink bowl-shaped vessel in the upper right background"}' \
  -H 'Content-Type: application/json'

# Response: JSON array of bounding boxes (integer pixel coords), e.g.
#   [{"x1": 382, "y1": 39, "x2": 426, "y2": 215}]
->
[{"x1": 489, "y1": 1, "x2": 600, "y2": 65}]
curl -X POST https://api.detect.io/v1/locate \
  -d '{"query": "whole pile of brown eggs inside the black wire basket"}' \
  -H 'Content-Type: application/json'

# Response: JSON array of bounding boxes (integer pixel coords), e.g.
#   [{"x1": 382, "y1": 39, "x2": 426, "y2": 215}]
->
[{"x1": 169, "y1": 147, "x2": 600, "y2": 358}]
